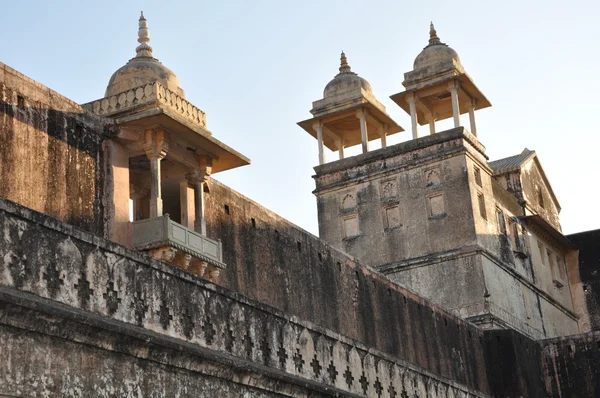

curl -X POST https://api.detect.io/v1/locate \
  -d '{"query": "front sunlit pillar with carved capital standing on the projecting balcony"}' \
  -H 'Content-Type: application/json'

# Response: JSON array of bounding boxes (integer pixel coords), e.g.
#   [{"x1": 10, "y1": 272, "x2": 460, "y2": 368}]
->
[{"x1": 144, "y1": 130, "x2": 169, "y2": 218}]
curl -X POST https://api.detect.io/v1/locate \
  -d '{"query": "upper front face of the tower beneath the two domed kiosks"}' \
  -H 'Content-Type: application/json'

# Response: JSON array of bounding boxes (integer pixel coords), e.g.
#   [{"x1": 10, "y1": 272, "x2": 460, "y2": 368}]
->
[{"x1": 314, "y1": 128, "x2": 485, "y2": 267}]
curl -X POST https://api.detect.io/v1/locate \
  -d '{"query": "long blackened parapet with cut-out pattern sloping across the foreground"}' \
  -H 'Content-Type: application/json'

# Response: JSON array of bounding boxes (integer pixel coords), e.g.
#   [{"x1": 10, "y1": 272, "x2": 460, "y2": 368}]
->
[{"x1": 0, "y1": 199, "x2": 486, "y2": 398}]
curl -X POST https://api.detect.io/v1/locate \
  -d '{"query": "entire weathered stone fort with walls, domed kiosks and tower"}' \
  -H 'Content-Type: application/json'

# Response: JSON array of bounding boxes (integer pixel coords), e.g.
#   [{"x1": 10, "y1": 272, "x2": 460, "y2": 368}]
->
[{"x1": 0, "y1": 14, "x2": 600, "y2": 398}]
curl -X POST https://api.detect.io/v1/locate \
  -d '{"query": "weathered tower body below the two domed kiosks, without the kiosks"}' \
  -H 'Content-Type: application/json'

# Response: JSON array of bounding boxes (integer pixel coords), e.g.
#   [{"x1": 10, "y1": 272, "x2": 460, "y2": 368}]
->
[{"x1": 315, "y1": 127, "x2": 582, "y2": 338}]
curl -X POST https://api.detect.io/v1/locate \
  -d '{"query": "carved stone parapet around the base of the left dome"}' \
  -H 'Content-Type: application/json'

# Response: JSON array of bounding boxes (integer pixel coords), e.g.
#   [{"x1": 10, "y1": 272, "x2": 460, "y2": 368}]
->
[{"x1": 82, "y1": 82, "x2": 206, "y2": 127}]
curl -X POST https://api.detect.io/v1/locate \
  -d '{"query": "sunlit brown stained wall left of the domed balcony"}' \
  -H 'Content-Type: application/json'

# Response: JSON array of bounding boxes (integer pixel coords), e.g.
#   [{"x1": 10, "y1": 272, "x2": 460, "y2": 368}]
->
[{"x1": 0, "y1": 63, "x2": 109, "y2": 235}]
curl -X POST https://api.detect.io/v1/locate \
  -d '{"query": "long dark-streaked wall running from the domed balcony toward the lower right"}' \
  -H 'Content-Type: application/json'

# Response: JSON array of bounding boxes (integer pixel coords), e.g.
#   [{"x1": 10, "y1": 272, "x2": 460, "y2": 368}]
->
[{"x1": 206, "y1": 180, "x2": 487, "y2": 391}]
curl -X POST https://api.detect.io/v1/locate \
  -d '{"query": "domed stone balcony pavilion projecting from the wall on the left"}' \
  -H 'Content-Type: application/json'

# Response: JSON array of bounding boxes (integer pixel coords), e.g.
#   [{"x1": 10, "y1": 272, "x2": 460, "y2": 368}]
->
[{"x1": 83, "y1": 13, "x2": 250, "y2": 280}]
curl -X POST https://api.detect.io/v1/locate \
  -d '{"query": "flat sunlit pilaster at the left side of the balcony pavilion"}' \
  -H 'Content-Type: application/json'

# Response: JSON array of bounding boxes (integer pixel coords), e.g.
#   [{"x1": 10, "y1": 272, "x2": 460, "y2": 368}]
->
[{"x1": 103, "y1": 140, "x2": 131, "y2": 247}]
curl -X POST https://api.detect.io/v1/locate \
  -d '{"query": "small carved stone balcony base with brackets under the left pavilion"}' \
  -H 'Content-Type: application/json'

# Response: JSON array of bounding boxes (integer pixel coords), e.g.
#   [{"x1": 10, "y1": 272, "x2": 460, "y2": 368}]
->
[{"x1": 133, "y1": 214, "x2": 226, "y2": 282}]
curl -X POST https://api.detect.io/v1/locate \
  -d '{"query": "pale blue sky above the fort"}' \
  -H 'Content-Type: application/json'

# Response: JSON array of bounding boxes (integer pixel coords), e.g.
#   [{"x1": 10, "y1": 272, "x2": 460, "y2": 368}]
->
[{"x1": 0, "y1": 0, "x2": 600, "y2": 234}]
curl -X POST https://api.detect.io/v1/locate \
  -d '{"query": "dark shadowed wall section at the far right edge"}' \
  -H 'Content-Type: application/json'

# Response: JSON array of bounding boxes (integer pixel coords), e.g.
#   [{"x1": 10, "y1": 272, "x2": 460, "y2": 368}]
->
[{"x1": 568, "y1": 229, "x2": 600, "y2": 331}]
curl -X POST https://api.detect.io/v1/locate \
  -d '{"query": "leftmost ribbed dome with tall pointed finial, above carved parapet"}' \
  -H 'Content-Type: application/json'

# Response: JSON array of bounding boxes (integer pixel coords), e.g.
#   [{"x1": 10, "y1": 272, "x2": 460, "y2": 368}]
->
[{"x1": 105, "y1": 13, "x2": 185, "y2": 97}]
